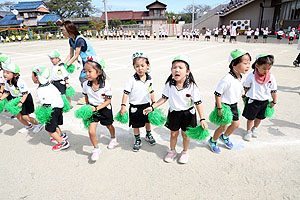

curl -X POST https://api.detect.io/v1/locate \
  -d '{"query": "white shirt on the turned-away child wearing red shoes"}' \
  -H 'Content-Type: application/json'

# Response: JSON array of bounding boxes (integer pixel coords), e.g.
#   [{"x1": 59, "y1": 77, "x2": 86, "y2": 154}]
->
[{"x1": 36, "y1": 83, "x2": 64, "y2": 108}]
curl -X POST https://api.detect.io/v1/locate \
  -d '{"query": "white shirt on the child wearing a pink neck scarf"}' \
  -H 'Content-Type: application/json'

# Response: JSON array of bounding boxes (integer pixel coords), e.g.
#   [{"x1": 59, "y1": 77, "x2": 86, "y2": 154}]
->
[{"x1": 244, "y1": 73, "x2": 277, "y2": 101}]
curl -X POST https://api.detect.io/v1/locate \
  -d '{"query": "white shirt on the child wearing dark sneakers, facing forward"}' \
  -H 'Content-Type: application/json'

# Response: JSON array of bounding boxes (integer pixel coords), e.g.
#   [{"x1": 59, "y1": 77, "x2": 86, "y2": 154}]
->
[{"x1": 124, "y1": 73, "x2": 154, "y2": 105}]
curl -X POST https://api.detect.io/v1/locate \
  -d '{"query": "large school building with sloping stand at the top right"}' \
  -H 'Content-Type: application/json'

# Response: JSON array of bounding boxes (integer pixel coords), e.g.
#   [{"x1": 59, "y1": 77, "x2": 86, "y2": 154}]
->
[{"x1": 195, "y1": 0, "x2": 300, "y2": 31}]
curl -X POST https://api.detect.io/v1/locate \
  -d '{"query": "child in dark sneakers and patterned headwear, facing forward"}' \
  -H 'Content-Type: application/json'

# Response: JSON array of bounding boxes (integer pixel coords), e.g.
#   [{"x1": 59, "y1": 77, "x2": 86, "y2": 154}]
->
[{"x1": 120, "y1": 52, "x2": 156, "y2": 152}]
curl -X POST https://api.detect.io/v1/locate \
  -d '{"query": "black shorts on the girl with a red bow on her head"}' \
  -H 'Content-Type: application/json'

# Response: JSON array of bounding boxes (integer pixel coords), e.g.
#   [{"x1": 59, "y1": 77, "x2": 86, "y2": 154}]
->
[{"x1": 91, "y1": 105, "x2": 114, "y2": 126}]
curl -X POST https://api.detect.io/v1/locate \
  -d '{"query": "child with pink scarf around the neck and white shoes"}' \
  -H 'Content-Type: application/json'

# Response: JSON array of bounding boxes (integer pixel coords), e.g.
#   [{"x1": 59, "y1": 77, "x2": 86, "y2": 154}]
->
[{"x1": 243, "y1": 54, "x2": 277, "y2": 141}]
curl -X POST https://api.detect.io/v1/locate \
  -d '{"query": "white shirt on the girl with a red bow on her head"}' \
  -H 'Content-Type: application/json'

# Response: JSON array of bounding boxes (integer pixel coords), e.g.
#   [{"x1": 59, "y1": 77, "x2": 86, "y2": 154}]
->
[{"x1": 82, "y1": 80, "x2": 112, "y2": 109}]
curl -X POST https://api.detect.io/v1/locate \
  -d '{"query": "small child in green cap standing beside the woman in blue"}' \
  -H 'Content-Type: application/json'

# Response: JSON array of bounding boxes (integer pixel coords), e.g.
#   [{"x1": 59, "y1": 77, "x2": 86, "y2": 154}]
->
[{"x1": 48, "y1": 50, "x2": 72, "y2": 108}]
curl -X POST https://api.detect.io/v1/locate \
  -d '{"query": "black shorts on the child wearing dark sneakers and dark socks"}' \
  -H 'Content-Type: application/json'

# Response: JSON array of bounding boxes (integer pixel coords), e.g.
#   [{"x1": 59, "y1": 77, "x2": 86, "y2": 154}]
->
[{"x1": 129, "y1": 103, "x2": 150, "y2": 128}]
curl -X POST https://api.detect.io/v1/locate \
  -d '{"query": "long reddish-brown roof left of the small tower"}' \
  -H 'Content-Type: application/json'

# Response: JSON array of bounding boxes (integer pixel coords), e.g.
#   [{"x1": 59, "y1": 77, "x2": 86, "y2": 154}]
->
[{"x1": 101, "y1": 10, "x2": 148, "y2": 21}]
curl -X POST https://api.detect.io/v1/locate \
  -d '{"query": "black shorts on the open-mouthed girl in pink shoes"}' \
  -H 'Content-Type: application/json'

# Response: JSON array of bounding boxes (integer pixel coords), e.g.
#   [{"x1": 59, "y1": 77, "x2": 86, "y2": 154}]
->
[{"x1": 166, "y1": 107, "x2": 197, "y2": 131}]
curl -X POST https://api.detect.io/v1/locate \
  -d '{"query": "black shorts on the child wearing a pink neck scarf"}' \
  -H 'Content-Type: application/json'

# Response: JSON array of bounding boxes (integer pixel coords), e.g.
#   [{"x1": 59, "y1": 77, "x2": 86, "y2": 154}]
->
[{"x1": 243, "y1": 98, "x2": 269, "y2": 120}]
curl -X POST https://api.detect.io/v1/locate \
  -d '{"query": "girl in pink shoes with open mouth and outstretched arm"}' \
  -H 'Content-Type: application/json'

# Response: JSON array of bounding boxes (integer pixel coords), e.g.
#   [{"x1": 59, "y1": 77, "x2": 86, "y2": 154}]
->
[{"x1": 144, "y1": 55, "x2": 208, "y2": 164}]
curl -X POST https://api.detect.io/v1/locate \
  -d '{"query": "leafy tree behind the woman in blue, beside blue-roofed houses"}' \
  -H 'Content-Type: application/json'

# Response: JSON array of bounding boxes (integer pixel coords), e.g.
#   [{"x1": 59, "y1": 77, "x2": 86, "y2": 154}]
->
[{"x1": 45, "y1": 0, "x2": 96, "y2": 18}]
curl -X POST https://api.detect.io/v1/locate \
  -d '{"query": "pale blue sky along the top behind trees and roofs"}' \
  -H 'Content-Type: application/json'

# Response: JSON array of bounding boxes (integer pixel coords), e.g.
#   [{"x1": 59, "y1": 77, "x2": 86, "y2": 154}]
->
[{"x1": 0, "y1": 0, "x2": 230, "y2": 13}]
